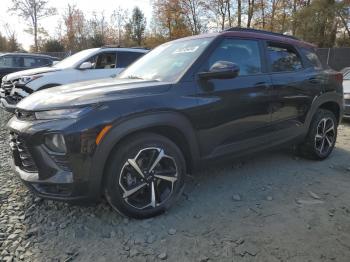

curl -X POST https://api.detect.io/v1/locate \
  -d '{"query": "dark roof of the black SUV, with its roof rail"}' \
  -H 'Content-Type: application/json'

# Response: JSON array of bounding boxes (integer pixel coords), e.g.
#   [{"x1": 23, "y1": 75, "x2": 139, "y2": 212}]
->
[{"x1": 175, "y1": 28, "x2": 316, "y2": 48}]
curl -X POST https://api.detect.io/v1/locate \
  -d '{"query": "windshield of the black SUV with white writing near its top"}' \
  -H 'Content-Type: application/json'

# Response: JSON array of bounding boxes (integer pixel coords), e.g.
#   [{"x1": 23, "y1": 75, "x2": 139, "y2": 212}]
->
[{"x1": 118, "y1": 38, "x2": 213, "y2": 82}]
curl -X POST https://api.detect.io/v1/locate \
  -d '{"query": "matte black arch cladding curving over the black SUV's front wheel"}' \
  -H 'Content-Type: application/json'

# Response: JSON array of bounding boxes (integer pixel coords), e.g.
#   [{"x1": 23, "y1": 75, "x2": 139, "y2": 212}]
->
[{"x1": 90, "y1": 112, "x2": 200, "y2": 199}]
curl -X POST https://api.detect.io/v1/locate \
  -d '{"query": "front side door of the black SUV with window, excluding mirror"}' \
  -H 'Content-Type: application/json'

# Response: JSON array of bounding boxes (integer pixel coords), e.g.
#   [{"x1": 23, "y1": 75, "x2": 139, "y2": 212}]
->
[{"x1": 197, "y1": 38, "x2": 271, "y2": 157}]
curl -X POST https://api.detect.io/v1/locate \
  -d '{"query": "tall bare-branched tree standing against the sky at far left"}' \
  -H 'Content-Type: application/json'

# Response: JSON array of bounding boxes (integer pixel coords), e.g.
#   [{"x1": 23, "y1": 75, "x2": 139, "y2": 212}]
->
[{"x1": 10, "y1": 0, "x2": 56, "y2": 52}]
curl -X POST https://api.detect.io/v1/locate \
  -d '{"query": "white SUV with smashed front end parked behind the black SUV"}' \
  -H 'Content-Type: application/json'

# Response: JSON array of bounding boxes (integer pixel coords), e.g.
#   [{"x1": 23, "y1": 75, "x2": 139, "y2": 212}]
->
[{"x1": 0, "y1": 47, "x2": 148, "y2": 112}]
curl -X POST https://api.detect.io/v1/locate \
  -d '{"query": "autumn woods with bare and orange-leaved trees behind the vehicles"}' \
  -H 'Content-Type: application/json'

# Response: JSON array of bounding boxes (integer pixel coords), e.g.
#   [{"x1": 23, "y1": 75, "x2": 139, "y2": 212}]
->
[{"x1": 0, "y1": 0, "x2": 350, "y2": 52}]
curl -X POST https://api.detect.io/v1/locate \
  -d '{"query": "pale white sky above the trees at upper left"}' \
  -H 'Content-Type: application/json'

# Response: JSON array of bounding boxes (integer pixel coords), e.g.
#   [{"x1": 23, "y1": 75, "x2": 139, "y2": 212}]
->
[{"x1": 0, "y1": 0, "x2": 152, "y2": 50}]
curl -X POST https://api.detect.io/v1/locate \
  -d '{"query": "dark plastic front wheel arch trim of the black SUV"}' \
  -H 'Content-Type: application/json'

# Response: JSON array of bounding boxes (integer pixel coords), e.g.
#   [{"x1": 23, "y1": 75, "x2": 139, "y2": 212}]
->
[{"x1": 91, "y1": 112, "x2": 200, "y2": 198}]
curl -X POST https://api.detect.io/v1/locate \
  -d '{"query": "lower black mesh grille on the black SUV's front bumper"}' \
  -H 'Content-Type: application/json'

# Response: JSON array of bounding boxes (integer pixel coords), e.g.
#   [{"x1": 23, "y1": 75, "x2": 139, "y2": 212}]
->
[{"x1": 10, "y1": 133, "x2": 38, "y2": 172}]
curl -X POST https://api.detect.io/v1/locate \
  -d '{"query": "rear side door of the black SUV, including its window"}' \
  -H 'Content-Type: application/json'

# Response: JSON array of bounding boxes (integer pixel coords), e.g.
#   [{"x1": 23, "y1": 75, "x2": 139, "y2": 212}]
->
[{"x1": 266, "y1": 42, "x2": 322, "y2": 140}]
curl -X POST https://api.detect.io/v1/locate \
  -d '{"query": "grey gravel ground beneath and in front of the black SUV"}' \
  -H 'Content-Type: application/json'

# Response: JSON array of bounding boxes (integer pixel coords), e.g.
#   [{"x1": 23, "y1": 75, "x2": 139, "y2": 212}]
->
[{"x1": 0, "y1": 108, "x2": 350, "y2": 262}]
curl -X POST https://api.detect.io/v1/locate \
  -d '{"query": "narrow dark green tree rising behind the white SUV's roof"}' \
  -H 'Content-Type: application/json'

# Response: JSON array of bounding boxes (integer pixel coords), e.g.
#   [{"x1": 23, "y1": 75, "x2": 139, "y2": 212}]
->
[{"x1": 126, "y1": 7, "x2": 146, "y2": 46}]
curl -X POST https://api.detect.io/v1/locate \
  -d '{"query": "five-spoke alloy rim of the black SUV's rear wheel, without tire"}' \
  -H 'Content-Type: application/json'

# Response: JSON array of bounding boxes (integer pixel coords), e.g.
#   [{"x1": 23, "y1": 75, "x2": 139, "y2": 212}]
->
[{"x1": 315, "y1": 118, "x2": 336, "y2": 155}]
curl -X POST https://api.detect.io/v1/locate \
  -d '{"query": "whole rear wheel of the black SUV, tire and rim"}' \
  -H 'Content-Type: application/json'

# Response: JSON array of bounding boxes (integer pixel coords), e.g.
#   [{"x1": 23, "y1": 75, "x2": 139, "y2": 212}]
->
[{"x1": 299, "y1": 109, "x2": 338, "y2": 160}]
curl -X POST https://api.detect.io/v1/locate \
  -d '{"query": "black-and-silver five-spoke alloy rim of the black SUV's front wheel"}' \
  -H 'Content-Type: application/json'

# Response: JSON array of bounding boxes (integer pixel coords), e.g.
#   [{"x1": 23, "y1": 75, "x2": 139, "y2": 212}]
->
[{"x1": 119, "y1": 147, "x2": 178, "y2": 210}]
